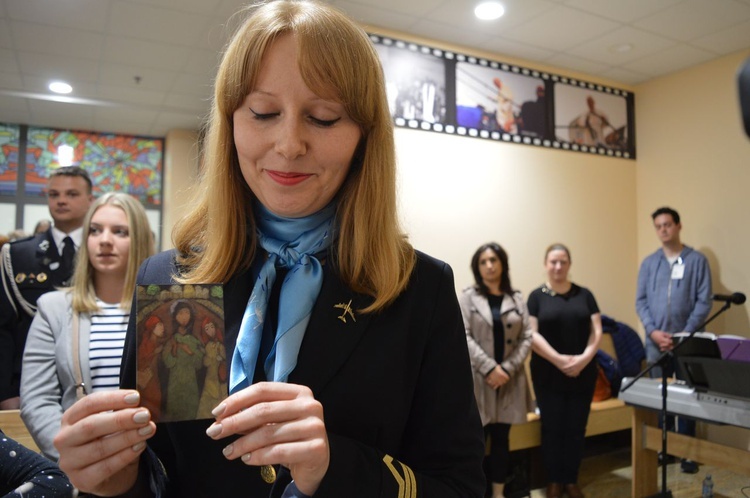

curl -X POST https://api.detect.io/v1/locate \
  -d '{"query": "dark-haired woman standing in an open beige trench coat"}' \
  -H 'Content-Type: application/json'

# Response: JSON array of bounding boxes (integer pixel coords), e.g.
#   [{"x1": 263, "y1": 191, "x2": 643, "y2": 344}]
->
[{"x1": 459, "y1": 242, "x2": 532, "y2": 498}]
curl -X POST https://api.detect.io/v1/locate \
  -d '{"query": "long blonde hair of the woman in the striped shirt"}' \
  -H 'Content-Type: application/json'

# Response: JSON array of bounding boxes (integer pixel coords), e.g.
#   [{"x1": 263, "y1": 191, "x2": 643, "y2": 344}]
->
[{"x1": 69, "y1": 192, "x2": 154, "y2": 313}]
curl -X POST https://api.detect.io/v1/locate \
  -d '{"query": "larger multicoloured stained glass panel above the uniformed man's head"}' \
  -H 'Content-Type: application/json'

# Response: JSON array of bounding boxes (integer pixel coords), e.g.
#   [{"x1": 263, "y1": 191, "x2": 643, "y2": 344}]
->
[{"x1": 26, "y1": 127, "x2": 164, "y2": 206}]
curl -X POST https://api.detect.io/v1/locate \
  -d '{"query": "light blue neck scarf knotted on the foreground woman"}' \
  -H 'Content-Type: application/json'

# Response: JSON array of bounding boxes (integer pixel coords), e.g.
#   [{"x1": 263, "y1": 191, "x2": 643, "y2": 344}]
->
[{"x1": 229, "y1": 202, "x2": 336, "y2": 393}]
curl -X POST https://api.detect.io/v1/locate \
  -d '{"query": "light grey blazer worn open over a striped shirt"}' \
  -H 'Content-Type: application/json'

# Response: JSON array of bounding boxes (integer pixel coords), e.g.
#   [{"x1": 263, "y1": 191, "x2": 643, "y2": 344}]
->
[{"x1": 21, "y1": 291, "x2": 91, "y2": 461}]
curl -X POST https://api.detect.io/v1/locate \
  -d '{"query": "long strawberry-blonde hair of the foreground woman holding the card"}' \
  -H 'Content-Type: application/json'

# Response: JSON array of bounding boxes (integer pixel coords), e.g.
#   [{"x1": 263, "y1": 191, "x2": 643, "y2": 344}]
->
[{"x1": 173, "y1": 0, "x2": 415, "y2": 312}]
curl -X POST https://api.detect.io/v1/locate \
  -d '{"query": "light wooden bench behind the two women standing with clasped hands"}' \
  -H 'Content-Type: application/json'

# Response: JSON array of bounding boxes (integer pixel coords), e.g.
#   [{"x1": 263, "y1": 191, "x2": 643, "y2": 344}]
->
[{"x1": 510, "y1": 333, "x2": 633, "y2": 451}]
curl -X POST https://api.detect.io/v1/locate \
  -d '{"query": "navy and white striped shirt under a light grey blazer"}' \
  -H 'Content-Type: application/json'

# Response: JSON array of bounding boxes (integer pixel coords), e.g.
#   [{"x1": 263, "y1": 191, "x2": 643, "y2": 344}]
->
[{"x1": 89, "y1": 299, "x2": 129, "y2": 392}]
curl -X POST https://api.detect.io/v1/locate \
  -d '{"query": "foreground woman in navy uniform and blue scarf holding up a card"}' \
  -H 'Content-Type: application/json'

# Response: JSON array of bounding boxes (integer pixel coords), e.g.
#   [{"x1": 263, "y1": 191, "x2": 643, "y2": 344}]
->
[{"x1": 56, "y1": 0, "x2": 485, "y2": 498}]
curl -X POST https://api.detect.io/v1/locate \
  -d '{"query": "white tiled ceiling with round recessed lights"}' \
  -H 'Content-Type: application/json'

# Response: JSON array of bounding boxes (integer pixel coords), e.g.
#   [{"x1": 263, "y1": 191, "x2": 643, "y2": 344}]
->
[{"x1": 0, "y1": 0, "x2": 750, "y2": 136}]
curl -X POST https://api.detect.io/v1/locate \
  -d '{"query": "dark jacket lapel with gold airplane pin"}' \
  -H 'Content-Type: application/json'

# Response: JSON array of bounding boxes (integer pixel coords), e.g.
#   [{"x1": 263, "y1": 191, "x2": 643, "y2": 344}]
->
[{"x1": 289, "y1": 268, "x2": 372, "y2": 395}]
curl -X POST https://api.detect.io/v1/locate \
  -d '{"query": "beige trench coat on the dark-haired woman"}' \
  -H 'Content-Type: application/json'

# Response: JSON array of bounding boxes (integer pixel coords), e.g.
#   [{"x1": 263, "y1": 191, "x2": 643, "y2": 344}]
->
[{"x1": 459, "y1": 286, "x2": 533, "y2": 425}]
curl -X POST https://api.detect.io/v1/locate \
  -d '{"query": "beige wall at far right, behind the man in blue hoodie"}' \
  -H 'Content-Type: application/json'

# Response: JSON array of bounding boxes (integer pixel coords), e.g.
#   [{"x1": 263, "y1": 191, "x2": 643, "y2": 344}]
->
[{"x1": 635, "y1": 51, "x2": 750, "y2": 337}]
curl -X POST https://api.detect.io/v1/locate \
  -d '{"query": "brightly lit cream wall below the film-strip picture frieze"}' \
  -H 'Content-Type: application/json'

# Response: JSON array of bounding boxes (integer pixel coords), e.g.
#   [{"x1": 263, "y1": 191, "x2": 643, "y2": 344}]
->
[{"x1": 396, "y1": 129, "x2": 636, "y2": 323}]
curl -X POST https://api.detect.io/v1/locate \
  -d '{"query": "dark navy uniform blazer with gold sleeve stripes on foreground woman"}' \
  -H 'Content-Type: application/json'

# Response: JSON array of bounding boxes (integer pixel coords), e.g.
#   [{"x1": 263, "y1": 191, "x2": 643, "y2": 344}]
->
[{"x1": 122, "y1": 252, "x2": 485, "y2": 498}]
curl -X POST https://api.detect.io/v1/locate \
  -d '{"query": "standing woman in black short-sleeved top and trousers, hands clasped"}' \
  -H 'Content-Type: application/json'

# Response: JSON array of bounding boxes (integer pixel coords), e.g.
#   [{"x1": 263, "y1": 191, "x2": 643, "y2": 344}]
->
[{"x1": 528, "y1": 244, "x2": 602, "y2": 498}]
